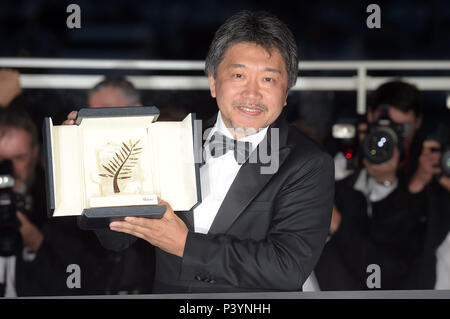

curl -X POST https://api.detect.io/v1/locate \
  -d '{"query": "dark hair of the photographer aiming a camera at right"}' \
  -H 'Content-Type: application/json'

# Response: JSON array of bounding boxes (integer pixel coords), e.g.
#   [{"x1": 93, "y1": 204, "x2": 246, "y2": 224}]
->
[{"x1": 369, "y1": 80, "x2": 422, "y2": 116}]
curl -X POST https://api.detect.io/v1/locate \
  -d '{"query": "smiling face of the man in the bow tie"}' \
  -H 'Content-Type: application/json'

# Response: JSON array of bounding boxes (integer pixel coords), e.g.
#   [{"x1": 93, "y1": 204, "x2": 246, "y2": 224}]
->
[{"x1": 209, "y1": 42, "x2": 288, "y2": 136}]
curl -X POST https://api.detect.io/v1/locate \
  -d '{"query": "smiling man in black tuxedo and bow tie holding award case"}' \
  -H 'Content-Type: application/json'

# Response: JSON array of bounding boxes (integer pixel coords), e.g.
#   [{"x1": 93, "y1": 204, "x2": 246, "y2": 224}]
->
[{"x1": 67, "y1": 11, "x2": 334, "y2": 293}]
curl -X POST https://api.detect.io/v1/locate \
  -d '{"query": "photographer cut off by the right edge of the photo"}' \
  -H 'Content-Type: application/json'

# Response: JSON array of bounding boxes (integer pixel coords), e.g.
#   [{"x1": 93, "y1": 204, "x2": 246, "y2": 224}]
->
[{"x1": 408, "y1": 124, "x2": 450, "y2": 289}]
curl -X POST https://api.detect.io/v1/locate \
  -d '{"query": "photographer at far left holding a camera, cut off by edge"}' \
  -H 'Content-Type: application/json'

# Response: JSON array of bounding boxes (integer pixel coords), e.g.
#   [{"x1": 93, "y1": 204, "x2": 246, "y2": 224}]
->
[{"x1": 0, "y1": 108, "x2": 79, "y2": 297}]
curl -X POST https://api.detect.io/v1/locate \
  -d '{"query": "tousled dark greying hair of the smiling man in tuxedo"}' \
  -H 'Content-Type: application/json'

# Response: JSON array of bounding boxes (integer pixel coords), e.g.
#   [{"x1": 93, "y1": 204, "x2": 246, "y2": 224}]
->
[{"x1": 205, "y1": 10, "x2": 298, "y2": 90}]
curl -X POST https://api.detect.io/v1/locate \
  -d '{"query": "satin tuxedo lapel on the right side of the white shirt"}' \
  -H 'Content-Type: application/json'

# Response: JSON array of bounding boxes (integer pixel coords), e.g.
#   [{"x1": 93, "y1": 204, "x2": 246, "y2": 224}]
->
[{"x1": 209, "y1": 112, "x2": 291, "y2": 234}]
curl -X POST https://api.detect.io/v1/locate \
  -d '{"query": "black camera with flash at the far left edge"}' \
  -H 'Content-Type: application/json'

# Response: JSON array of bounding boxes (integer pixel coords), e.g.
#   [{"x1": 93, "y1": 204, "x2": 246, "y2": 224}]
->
[{"x1": 0, "y1": 160, "x2": 31, "y2": 257}]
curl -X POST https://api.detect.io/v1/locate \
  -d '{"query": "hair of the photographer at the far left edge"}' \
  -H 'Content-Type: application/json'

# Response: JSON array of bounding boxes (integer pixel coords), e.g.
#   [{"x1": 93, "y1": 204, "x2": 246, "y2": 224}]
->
[{"x1": 0, "y1": 107, "x2": 39, "y2": 146}]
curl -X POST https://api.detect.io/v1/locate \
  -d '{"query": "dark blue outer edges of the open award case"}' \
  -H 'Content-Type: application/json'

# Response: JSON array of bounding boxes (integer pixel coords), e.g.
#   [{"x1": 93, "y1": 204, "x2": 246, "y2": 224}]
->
[{"x1": 43, "y1": 106, "x2": 201, "y2": 230}]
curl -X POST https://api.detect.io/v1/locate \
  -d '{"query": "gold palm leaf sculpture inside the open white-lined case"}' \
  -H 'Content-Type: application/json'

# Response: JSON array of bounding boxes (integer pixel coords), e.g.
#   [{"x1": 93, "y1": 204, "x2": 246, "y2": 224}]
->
[{"x1": 99, "y1": 140, "x2": 142, "y2": 193}]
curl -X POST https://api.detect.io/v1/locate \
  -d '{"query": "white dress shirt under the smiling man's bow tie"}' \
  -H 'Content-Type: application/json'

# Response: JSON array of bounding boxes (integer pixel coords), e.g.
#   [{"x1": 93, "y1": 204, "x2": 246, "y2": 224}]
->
[{"x1": 194, "y1": 112, "x2": 268, "y2": 234}]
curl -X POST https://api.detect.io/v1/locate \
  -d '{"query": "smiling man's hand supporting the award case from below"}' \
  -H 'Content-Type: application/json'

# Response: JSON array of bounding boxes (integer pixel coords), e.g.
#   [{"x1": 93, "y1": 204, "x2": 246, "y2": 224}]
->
[{"x1": 109, "y1": 200, "x2": 188, "y2": 257}]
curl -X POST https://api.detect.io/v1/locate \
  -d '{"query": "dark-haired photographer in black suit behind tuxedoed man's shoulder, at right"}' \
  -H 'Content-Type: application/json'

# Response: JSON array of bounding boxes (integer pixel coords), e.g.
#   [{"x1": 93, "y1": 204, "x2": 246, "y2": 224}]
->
[{"x1": 315, "y1": 81, "x2": 437, "y2": 290}]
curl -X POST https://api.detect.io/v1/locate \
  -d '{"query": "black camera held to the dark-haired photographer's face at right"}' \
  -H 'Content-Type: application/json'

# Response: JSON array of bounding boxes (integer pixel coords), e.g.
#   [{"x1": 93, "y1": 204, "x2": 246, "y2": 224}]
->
[{"x1": 361, "y1": 105, "x2": 411, "y2": 164}]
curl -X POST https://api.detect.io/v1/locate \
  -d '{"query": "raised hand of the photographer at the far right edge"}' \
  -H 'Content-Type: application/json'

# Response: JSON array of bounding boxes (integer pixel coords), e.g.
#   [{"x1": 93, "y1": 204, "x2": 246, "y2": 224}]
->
[{"x1": 408, "y1": 140, "x2": 441, "y2": 194}]
